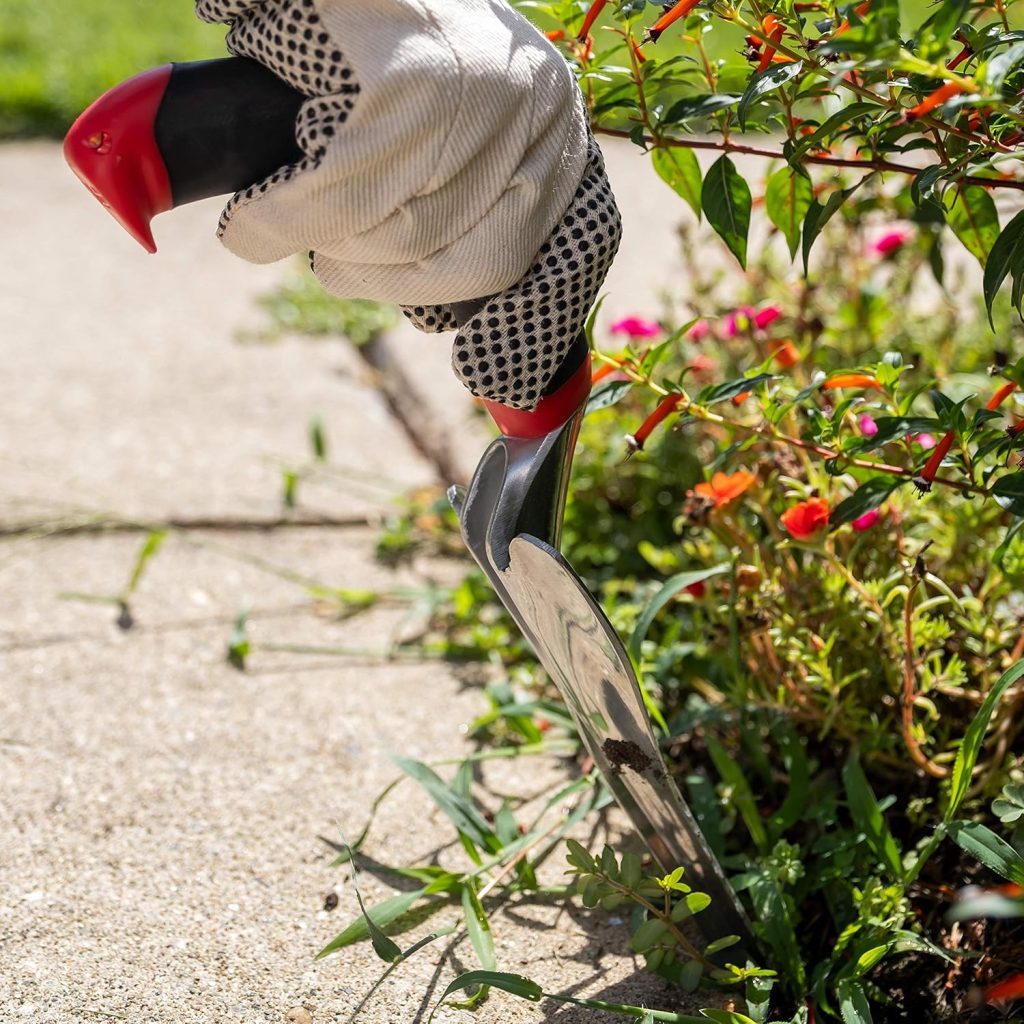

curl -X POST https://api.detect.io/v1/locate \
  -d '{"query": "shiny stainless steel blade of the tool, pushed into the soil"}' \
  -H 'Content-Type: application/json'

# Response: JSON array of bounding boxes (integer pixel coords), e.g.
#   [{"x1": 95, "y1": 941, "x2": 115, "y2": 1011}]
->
[{"x1": 450, "y1": 411, "x2": 755, "y2": 958}]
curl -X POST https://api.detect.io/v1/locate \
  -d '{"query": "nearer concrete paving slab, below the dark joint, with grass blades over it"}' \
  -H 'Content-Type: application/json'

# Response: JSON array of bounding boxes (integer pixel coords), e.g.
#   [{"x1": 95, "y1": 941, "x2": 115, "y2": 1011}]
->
[{"x1": 0, "y1": 529, "x2": 712, "y2": 1024}]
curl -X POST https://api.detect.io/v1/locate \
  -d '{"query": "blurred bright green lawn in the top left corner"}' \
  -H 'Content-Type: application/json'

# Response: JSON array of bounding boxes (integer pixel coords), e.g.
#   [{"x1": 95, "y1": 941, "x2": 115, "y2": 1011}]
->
[{"x1": 0, "y1": 0, "x2": 224, "y2": 138}]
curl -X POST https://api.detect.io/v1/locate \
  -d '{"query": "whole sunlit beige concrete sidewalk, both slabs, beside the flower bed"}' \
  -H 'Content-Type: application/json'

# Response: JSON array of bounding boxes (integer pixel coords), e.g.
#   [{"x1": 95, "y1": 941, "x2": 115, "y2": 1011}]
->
[{"x1": 0, "y1": 144, "x2": 700, "y2": 1024}]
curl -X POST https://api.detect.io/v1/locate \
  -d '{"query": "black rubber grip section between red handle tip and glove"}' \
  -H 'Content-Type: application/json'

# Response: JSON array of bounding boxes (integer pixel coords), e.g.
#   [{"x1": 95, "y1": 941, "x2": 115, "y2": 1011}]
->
[{"x1": 154, "y1": 57, "x2": 305, "y2": 206}]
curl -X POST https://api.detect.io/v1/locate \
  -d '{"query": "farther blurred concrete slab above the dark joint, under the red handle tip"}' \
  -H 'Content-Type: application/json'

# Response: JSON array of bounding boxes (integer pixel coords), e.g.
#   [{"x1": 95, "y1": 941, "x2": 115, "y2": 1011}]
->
[{"x1": 0, "y1": 142, "x2": 434, "y2": 522}]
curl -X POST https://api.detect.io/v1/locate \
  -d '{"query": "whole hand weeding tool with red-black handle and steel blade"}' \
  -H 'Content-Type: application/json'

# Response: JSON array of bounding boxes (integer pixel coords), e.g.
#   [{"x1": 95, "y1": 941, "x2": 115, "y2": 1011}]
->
[{"x1": 65, "y1": 57, "x2": 755, "y2": 961}]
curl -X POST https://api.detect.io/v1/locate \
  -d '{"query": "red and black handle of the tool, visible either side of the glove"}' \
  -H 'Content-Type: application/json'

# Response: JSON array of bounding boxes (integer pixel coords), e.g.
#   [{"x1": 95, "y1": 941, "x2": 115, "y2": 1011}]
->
[{"x1": 63, "y1": 57, "x2": 591, "y2": 437}]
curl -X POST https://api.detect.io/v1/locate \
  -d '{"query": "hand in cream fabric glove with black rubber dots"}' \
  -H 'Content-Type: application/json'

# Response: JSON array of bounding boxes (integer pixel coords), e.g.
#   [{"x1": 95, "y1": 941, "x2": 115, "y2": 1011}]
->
[{"x1": 196, "y1": 0, "x2": 621, "y2": 409}]
